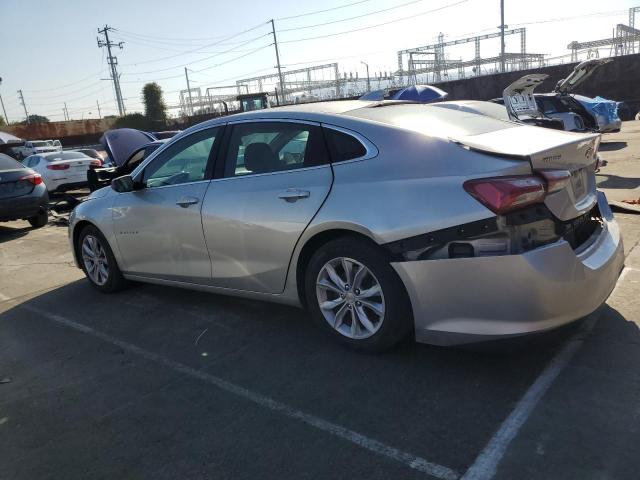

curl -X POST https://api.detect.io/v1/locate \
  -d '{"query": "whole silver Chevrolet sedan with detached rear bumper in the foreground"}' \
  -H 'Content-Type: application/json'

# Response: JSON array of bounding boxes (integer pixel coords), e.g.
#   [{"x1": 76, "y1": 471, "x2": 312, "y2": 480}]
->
[{"x1": 69, "y1": 101, "x2": 624, "y2": 351}]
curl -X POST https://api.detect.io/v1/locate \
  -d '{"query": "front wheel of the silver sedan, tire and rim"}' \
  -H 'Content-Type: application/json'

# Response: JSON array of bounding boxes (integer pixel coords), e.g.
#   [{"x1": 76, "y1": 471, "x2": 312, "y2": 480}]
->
[{"x1": 76, "y1": 225, "x2": 127, "y2": 293}]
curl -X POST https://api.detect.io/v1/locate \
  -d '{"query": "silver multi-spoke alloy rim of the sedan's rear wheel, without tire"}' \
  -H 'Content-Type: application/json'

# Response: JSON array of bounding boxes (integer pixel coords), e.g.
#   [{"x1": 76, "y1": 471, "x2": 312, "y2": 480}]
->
[{"x1": 316, "y1": 257, "x2": 385, "y2": 340}]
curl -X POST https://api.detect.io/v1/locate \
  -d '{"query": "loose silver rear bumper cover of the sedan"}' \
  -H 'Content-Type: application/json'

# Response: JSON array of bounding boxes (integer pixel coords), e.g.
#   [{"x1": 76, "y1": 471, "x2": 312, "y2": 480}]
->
[{"x1": 392, "y1": 192, "x2": 624, "y2": 345}]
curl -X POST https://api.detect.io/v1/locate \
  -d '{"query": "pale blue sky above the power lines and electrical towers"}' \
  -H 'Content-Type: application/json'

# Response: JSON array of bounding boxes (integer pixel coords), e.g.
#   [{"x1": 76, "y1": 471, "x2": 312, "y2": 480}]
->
[{"x1": 0, "y1": 0, "x2": 640, "y2": 121}]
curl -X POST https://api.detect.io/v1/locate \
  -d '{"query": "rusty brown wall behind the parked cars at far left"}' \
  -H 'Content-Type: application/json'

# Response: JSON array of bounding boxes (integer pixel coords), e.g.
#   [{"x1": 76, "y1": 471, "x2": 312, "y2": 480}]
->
[{"x1": 3, "y1": 118, "x2": 115, "y2": 146}]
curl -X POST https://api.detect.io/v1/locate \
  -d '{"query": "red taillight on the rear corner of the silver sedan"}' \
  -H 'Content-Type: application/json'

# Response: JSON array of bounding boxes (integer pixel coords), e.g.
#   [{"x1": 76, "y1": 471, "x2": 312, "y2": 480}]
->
[{"x1": 463, "y1": 176, "x2": 546, "y2": 214}]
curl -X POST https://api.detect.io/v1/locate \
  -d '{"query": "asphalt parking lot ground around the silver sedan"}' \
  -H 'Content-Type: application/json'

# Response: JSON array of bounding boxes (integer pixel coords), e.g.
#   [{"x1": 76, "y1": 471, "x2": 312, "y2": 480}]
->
[{"x1": 0, "y1": 122, "x2": 640, "y2": 479}]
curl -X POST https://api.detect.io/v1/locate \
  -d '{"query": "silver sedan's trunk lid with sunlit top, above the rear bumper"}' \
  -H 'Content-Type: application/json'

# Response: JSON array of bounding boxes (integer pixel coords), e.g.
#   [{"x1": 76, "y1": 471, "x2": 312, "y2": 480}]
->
[{"x1": 452, "y1": 126, "x2": 600, "y2": 221}]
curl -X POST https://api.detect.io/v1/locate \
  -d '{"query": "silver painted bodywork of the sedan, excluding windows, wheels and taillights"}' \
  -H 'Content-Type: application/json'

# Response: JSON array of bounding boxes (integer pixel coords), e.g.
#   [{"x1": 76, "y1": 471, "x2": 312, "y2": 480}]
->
[{"x1": 69, "y1": 101, "x2": 622, "y2": 343}]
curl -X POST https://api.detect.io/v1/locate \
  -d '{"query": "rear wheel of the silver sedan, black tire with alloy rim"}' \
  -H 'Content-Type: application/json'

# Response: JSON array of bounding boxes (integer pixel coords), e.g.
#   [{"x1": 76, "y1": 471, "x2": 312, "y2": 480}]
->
[{"x1": 305, "y1": 237, "x2": 413, "y2": 352}]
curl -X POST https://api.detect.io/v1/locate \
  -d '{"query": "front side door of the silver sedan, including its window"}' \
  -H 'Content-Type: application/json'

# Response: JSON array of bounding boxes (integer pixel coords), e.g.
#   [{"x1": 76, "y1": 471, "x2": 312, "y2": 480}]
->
[{"x1": 113, "y1": 127, "x2": 222, "y2": 283}]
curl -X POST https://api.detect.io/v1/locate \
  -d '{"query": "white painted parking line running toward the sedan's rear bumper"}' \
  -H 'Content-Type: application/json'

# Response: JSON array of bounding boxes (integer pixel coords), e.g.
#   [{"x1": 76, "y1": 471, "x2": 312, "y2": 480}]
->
[{"x1": 461, "y1": 311, "x2": 599, "y2": 480}]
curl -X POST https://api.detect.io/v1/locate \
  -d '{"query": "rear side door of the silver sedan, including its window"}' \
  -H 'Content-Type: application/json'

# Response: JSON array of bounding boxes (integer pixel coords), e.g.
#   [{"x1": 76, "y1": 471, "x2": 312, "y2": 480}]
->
[{"x1": 202, "y1": 120, "x2": 333, "y2": 293}]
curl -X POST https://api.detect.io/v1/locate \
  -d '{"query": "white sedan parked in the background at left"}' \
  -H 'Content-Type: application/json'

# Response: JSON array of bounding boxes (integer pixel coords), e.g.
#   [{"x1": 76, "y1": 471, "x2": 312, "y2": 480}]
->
[{"x1": 22, "y1": 152, "x2": 102, "y2": 192}]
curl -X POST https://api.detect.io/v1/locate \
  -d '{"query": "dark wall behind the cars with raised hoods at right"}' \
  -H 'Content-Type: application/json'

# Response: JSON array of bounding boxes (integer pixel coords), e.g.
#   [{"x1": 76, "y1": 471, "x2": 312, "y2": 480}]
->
[{"x1": 438, "y1": 54, "x2": 640, "y2": 111}]
